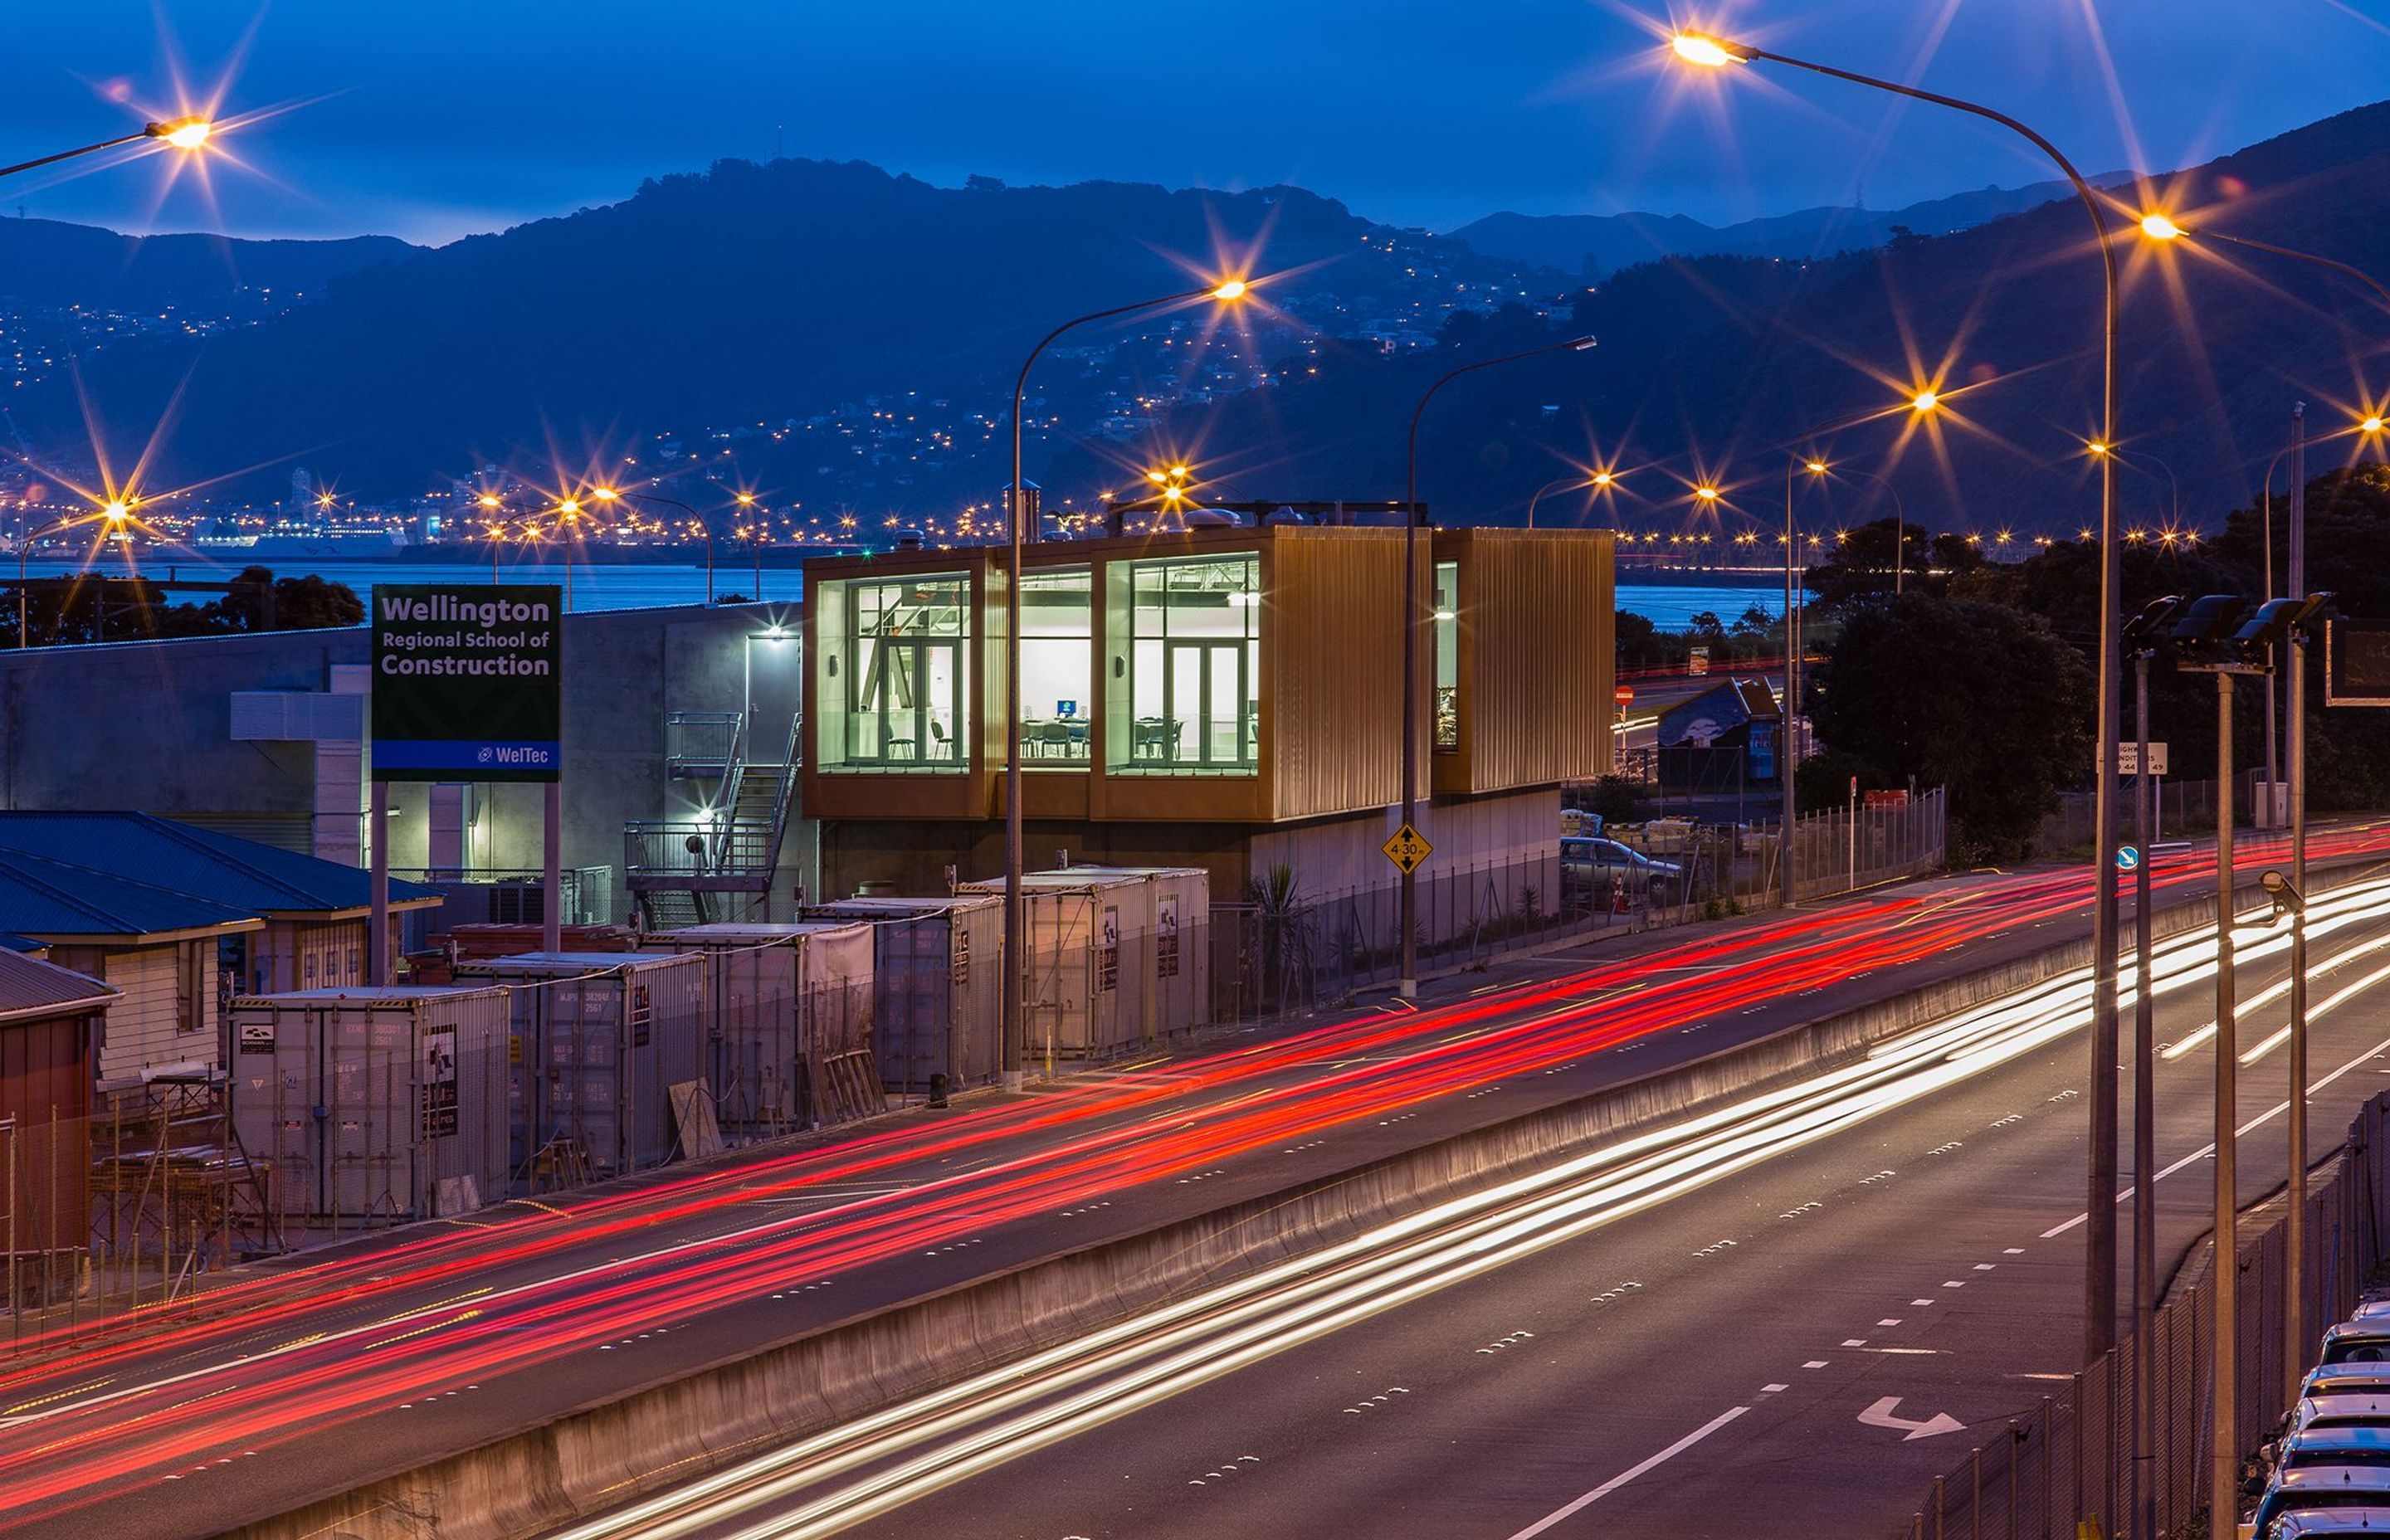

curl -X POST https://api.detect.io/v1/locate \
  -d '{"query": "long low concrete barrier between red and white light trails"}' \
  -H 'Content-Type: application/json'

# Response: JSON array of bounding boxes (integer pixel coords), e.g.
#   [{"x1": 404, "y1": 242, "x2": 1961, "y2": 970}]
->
[{"x1": 227, "y1": 887, "x2": 2294, "y2": 1540}]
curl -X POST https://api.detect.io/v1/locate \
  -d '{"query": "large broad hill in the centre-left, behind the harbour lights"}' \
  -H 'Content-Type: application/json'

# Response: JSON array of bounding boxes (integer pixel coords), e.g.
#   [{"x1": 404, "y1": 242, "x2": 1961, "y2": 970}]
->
[{"x1": 12, "y1": 160, "x2": 1558, "y2": 504}]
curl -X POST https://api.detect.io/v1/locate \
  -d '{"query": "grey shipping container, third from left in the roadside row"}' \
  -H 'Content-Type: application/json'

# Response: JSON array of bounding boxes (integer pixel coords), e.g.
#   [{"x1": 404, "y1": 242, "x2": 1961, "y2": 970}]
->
[{"x1": 646, "y1": 921, "x2": 880, "y2": 1141}]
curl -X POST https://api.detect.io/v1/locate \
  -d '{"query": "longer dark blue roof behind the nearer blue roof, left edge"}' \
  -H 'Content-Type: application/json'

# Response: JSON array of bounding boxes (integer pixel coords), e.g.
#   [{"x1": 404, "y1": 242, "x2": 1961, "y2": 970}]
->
[{"x1": 0, "y1": 813, "x2": 440, "y2": 930}]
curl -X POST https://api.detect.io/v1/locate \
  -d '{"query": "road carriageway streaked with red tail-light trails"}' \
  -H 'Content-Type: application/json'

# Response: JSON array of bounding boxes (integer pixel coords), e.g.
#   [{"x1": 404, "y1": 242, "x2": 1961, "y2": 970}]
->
[{"x1": 0, "y1": 830, "x2": 2383, "y2": 1535}]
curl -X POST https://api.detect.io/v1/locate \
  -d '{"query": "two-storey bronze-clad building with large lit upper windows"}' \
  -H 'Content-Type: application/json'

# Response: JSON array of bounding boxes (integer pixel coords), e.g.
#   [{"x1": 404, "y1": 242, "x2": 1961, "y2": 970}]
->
[{"x1": 801, "y1": 524, "x2": 1613, "y2": 899}]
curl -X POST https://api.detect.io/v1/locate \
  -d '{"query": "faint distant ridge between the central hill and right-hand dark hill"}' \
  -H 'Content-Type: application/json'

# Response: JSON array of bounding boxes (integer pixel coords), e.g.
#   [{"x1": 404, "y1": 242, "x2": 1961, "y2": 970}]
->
[{"x1": 1448, "y1": 173, "x2": 2132, "y2": 275}]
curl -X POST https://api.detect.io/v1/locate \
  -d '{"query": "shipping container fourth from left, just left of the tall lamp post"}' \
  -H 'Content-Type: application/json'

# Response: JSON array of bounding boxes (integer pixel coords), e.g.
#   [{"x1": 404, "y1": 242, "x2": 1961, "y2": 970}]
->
[{"x1": 803, "y1": 894, "x2": 1004, "y2": 1095}]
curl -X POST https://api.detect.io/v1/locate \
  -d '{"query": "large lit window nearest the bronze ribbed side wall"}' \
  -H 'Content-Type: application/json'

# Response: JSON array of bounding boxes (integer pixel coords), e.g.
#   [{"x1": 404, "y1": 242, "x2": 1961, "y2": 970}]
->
[{"x1": 1105, "y1": 553, "x2": 1262, "y2": 775}]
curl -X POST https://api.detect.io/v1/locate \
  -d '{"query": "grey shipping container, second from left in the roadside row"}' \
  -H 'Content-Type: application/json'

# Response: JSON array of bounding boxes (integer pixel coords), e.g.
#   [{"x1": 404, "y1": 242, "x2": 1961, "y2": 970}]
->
[{"x1": 464, "y1": 952, "x2": 707, "y2": 1193}]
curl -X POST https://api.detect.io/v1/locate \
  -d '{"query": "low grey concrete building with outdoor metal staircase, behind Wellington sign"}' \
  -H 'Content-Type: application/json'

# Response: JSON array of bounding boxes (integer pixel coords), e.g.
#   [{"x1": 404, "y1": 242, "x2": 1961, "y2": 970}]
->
[{"x1": 0, "y1": 602, "x2": 812, "y2": 932}]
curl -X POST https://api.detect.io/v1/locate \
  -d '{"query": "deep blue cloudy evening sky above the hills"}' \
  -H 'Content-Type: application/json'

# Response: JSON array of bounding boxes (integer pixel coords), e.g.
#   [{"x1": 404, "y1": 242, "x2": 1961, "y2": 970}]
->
[{"x1": 0, "y1": 0, "x2": 2390, "y2": 241}]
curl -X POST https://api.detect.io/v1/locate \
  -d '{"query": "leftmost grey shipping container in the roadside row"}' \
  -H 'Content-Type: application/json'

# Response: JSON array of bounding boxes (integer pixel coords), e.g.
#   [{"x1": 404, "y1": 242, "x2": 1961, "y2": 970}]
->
[{"x1": 232, "y1": 987, "x2": 511, "y2": 1226}]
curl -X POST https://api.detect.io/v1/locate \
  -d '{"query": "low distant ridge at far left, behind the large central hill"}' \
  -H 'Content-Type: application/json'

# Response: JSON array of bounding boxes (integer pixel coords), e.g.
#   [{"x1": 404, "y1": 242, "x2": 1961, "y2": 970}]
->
[{"x1": 0, "y1": 217, "x2": 426, "y2": 311}]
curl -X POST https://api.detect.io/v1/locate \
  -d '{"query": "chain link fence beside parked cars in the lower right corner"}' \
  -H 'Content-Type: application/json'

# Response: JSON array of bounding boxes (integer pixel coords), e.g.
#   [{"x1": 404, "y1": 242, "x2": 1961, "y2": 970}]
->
[{"x1": 1898, "y1": 1093, "x2": 2390, "y2": 1540}]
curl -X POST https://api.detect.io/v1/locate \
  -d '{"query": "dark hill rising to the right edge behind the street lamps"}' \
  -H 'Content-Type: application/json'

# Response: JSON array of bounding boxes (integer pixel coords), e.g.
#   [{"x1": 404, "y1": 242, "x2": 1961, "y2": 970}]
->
[{"x1": 1095, "y1": 103, "x2": 2390, "y2": 535}]
